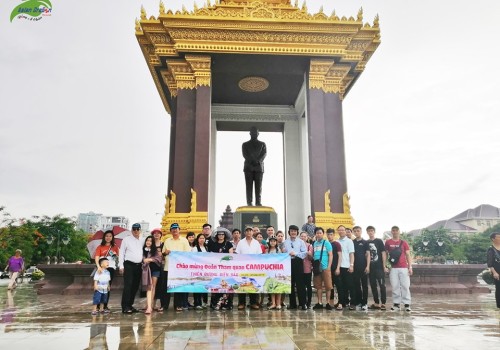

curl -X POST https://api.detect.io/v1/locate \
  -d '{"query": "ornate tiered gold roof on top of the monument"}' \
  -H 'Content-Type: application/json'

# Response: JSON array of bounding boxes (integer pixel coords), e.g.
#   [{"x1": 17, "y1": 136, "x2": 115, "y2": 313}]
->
[{"x1": 135, "y1": 0, "x2": 380, "y2": 110}]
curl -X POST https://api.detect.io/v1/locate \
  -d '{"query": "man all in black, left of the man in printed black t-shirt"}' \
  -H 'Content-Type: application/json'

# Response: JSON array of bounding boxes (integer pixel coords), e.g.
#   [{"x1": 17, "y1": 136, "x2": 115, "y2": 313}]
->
[{"x1": 352, "y1": 226, "x2": 370, "y2": 311}]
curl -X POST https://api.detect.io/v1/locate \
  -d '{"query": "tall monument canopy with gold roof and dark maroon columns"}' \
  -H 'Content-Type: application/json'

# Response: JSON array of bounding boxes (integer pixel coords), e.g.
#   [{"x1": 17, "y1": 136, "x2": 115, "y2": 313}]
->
[{"x1": 136, "y1": 0, "x2": 380, "y2": 231}]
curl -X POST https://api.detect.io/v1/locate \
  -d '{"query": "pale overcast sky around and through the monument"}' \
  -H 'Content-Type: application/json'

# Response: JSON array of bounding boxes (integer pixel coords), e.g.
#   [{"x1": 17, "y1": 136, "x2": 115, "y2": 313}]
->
[{"x1": 0, "y1": 0, "x2": 500, "y2": 233}]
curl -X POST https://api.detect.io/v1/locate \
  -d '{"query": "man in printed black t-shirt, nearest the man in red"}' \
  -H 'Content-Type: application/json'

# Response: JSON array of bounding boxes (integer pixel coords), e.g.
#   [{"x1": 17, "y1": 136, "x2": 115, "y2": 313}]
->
[{"x1": 366, "y1": 226, "x2": 387, "y2": 310}]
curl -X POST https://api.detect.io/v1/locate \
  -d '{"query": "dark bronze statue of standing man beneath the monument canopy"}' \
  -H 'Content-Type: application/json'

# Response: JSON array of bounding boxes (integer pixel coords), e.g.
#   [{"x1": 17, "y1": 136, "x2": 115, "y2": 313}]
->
[{"x1": 241, "y1": 126, "x2": 267, "y2": 206}]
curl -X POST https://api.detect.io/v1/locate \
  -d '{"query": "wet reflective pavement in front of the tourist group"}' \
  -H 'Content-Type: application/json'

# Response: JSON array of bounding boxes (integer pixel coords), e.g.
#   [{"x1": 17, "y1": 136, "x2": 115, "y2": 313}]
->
[{"x1": 0, "y1": 280, "x2": 500, "y2": 350}]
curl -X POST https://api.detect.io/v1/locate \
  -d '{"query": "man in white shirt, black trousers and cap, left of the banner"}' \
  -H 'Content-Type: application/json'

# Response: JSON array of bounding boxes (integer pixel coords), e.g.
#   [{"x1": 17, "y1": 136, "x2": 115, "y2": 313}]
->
[{"x1": 118, "y1": 223, "x2": 144, "y2": 314}]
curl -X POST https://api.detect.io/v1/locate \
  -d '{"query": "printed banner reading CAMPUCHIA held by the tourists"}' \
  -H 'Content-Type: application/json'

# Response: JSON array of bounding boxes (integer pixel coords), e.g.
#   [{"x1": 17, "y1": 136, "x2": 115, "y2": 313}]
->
[{"x1": 167, "y1": 252, "x2": 292, "y2": 294}]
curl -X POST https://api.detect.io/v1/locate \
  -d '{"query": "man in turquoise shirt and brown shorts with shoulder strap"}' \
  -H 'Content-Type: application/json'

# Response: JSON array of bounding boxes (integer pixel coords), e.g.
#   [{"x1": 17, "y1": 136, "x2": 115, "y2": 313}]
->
[{"x1": 313, "y1": 227, "x2": 333, "y2": 310}]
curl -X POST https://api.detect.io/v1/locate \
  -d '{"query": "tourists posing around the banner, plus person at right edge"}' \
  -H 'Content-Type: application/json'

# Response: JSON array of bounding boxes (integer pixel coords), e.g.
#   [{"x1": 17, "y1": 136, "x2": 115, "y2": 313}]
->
[{"x1": 85, "y1": 217, "x2": 500, "y2": 314}]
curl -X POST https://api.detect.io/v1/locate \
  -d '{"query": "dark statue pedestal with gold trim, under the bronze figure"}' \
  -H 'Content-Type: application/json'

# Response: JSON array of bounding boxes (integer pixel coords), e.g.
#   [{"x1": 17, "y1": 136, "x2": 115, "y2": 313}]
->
[{"x1": 233, "y1": 206, "x2": 278, "y2": 239}]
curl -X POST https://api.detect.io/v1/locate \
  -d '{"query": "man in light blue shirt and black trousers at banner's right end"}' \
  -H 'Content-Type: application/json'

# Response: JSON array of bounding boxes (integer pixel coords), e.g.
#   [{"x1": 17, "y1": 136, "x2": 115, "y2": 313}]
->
[{"x1": 282, "y1": 225, "x2": 307, "y2": 310}]
